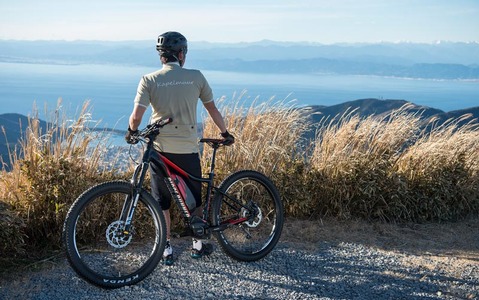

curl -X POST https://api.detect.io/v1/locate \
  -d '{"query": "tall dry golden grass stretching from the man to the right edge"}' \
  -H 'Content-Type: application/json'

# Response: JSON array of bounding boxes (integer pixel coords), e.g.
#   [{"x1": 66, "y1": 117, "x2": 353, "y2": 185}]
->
[{"x1": 203, "y1": 101, "x2": 479, "y2": 222}]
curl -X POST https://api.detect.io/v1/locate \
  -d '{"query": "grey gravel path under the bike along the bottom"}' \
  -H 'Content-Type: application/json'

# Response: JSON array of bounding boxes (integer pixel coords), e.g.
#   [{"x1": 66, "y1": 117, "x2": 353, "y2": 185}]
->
[{"x1": 0, "y1": 238, "x2": 479, "y2": 300}]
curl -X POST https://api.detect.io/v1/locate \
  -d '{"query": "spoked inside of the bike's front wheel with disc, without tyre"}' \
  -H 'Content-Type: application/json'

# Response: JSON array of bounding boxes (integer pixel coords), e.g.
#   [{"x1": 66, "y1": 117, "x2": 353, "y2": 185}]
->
[{"x1": 75, "y1": 194, "x2": 156, "y2": 276}]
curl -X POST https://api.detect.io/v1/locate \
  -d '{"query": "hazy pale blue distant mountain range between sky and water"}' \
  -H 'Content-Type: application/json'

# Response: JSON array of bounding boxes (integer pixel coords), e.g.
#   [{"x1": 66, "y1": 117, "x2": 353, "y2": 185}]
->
[{"x1": 0, "y1": 40, "x2": 479, "y2": 80}]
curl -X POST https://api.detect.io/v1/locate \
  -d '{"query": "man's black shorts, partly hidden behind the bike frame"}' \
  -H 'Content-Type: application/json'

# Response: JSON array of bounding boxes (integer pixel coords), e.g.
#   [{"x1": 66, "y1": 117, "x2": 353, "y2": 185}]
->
[{"x1": 150, "y1": 152, "x2": 201, "y2": 210}]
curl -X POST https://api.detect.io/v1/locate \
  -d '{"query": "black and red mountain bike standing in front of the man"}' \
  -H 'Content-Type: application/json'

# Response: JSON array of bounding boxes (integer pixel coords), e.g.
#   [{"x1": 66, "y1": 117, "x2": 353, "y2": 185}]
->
[{"x1": 63, "y1": 119, "x2": 284, "y2": 288}]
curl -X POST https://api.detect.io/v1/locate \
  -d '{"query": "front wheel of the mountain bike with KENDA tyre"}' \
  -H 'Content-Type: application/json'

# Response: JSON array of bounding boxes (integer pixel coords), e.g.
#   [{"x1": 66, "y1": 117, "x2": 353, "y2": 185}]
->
[{"x1": 63, "y1": 181, "x2": 166, "y2": 288}]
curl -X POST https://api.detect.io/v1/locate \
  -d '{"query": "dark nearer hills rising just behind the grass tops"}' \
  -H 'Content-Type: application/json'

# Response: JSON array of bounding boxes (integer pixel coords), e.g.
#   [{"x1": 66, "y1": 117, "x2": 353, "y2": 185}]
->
[{"x1": 0, "y1": 98, "x2": 479, "y2": 169}]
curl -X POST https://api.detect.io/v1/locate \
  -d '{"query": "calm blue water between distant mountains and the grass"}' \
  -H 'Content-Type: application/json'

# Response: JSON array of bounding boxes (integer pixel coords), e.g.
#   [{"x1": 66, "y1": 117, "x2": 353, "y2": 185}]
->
[{"x1": 0, "y1": 63, "x2": 479, "y2": 129}]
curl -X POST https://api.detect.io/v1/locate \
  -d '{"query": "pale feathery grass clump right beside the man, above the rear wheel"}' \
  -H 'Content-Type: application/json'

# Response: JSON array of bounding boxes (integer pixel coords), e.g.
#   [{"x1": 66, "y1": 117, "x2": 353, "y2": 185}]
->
[{"x1": 202, "y1": 94, "x2": 308, "y2": 177}]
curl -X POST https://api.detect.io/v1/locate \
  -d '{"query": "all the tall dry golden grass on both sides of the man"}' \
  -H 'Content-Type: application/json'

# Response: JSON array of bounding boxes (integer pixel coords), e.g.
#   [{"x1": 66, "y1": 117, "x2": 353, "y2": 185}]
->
[{"x1": 0, "y1": 95, "x2": 479, "y2": 270}]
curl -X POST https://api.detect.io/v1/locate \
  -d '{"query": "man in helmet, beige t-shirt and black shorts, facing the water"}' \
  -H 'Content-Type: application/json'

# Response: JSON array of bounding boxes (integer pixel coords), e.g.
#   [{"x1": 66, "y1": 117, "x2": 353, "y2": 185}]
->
[{"x1": 125, "y1": 31, "x2": 234, "y2": 265}]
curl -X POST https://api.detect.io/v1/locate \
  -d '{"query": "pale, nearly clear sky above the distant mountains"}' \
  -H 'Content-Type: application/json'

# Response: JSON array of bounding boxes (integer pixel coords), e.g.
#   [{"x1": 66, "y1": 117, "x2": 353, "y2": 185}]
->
[{"x1": 0, "y1": 0, "x2": 479, "y2": 44}]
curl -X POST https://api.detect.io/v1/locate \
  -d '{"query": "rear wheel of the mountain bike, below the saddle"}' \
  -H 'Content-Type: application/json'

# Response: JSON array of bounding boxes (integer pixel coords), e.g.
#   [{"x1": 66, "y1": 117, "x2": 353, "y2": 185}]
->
[{"x1": 211, "y1": 170, "x2": 284, "y2": 261}]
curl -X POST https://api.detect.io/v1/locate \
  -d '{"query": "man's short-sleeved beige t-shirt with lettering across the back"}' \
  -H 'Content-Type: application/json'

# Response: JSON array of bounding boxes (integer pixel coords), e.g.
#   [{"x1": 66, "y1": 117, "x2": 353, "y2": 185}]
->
[{"x1": 135, "y1": 63, "x2": 213, "y2": 153}]
